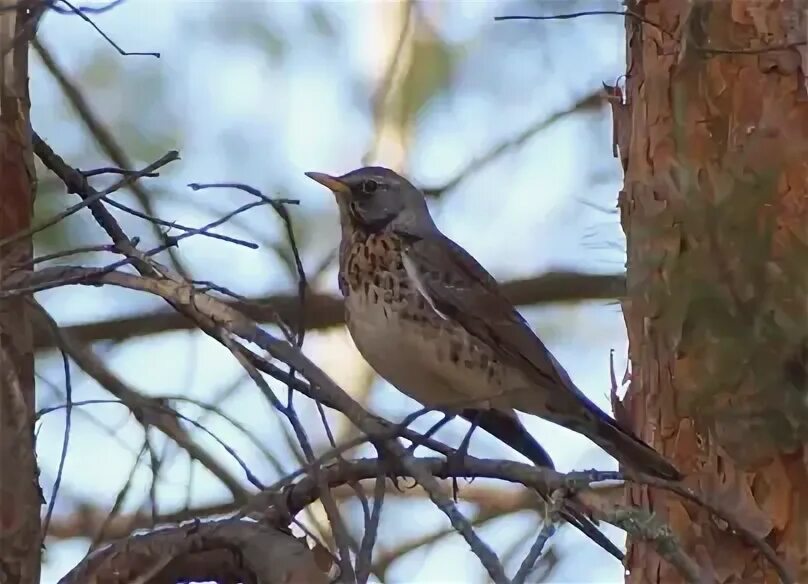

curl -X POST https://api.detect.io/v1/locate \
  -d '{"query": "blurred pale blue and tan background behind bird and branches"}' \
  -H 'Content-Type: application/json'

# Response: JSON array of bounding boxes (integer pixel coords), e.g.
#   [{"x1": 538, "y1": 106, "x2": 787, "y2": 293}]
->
[{"x1": 31, "y1": 0, "x2": 626, "y2": 583}]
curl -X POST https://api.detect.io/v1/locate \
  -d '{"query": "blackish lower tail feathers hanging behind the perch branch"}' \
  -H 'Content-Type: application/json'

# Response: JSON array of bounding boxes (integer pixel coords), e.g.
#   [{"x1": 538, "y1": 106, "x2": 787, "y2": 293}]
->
[{"x1": 468, "y1": 409, "x2": 625, "y2": 562}]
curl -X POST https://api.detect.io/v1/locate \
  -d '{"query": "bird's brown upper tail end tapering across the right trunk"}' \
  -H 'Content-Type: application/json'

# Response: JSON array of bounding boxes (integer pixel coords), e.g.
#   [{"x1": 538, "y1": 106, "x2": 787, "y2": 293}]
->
[{"x1": 576, "y1": 400, "x2": 682, "y2": 481}]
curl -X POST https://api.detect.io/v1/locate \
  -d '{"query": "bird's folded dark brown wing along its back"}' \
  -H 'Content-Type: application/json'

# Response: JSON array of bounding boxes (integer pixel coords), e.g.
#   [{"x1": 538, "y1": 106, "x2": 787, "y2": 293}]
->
[{"x1": 400, "y1": 234, "x2": 578, "y2": 392}]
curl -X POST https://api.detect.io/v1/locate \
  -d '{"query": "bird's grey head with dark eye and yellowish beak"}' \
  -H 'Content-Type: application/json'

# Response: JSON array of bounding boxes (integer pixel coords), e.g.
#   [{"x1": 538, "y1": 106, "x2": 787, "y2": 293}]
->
[{"x1": 306, "y1": 166, "x2": 434, "y2": 233}]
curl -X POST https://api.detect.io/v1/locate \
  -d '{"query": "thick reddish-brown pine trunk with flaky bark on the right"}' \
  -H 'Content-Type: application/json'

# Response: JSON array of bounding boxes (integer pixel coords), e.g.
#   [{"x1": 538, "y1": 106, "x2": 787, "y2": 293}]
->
[{"x1": 614, "y1": 0, "x2": 808, "y2": 584}]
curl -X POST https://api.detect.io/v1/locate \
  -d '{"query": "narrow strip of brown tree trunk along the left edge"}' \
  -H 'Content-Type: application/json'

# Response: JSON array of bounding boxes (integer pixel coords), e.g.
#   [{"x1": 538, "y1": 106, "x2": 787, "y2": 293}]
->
[{"x1": 0, "y1": 0, "x2": 42, "y2": 584}]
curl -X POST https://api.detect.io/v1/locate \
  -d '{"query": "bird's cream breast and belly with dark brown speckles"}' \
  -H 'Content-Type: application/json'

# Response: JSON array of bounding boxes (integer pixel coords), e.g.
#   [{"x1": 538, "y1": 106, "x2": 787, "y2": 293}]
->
[{"x1": 340, "y1": 234, "x2": 503, "y2": 407}]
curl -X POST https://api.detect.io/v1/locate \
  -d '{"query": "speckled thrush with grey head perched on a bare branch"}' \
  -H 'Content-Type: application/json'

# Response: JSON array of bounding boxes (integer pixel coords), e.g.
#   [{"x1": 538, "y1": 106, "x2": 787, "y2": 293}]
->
[{"x1": 305, "y1": 166, "x2": 682, "y2": 556}]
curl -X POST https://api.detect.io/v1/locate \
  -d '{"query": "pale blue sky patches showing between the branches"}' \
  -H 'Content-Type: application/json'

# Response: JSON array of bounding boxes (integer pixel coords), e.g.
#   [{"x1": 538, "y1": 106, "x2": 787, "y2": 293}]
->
[{"x1": 31, "y1": 0, "x2": 626, "y2": 584}]
